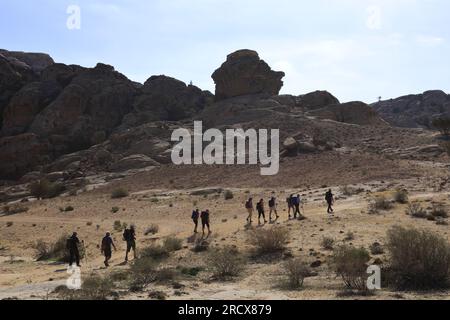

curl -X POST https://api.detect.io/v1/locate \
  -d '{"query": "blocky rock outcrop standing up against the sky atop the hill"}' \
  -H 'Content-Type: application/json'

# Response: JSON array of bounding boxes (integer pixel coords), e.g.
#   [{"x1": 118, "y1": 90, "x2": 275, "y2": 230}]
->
[{"x1": 212, "y1": 50, "x2": 285, "y2": 100}]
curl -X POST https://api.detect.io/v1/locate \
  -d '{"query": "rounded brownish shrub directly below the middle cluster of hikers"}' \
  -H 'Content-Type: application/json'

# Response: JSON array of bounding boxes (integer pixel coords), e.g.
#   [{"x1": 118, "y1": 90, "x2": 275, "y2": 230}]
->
[{"x1": 249, "y1": 227, "x2": 289, "y2": 254}]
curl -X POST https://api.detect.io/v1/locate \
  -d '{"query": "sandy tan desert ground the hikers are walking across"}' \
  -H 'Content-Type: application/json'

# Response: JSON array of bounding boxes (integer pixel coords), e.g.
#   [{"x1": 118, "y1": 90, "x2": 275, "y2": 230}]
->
[{"x1": 0, "y1": 154, "x2": 450, "y2": 299}]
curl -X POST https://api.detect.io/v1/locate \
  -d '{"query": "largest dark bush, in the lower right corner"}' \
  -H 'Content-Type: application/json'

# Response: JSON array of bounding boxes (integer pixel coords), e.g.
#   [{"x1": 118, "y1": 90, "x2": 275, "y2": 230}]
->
[{"x1": 388, "y1": 226, "x2": 450, "y2": 290}]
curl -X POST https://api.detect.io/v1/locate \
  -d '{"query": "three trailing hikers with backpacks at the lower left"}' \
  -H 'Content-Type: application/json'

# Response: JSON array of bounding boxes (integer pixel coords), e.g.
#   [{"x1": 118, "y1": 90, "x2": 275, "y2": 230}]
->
[{"x1": 66, "y1": 226, "x2": 136, "y2": 267}]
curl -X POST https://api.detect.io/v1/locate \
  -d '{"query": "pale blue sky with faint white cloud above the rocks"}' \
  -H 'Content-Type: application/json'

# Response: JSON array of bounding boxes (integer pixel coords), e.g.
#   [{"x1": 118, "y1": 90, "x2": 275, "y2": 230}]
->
[{"x1": 0, "y1": 0, "x2": 450, "y2": 102}]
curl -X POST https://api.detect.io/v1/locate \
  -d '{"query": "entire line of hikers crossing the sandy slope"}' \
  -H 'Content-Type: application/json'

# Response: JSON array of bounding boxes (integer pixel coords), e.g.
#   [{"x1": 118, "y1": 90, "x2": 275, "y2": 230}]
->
[{"x1": 66, "y1": 189, "x2": 335, "y2": 267}]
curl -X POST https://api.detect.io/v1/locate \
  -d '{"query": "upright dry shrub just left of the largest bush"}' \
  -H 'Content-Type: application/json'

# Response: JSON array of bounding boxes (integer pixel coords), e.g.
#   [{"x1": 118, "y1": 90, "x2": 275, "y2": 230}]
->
[{"x1": 333, "y1": 246, "x2": 370, "y2": 291}]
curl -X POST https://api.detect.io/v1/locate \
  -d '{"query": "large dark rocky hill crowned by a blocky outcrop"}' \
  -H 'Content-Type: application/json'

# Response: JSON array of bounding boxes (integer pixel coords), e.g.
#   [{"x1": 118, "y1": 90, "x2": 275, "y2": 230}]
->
[{"x1": 0, "y1": 46, "x2": 436, "y2": 185}]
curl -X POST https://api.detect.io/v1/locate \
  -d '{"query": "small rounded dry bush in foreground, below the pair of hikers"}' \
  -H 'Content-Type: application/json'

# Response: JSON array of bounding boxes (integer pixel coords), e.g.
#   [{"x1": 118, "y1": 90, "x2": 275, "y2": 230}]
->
[{"x1": 207, "y1": 246, "x2": 243, "y2": 279}]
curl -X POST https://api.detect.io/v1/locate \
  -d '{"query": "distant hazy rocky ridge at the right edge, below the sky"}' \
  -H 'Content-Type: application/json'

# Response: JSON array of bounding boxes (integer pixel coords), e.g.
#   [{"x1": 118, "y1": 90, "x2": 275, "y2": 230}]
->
[{"x1": 372, "y1": 90, "x2": 450, "y2": 128}]
